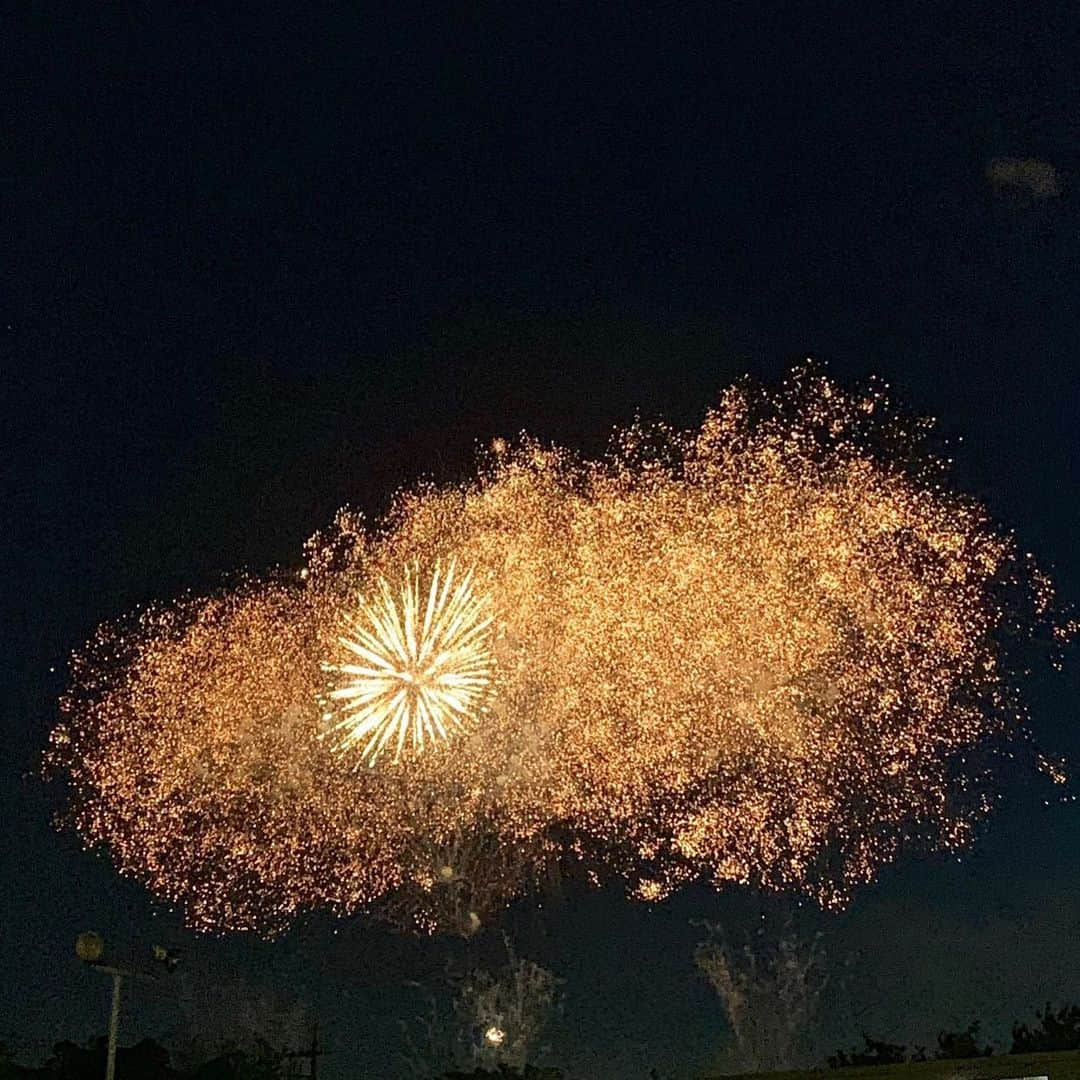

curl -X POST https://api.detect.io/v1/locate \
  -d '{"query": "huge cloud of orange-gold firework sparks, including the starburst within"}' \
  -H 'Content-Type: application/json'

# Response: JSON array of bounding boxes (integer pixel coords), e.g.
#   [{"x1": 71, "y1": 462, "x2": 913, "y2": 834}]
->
[{"x1": 49, "y1": 368, "x2": 1051, "y2": 933}]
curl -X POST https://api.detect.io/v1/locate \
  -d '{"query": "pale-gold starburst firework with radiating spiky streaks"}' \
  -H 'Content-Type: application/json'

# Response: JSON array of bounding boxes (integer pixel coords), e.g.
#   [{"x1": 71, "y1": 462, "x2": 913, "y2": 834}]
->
[{"x1": 323, "y1": 559, "x2": 494, "y2": 766}]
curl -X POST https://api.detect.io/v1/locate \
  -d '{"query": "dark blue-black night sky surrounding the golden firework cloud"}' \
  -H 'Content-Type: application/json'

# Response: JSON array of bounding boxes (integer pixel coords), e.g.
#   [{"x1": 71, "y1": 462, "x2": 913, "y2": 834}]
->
[{"x1": 6, "y1": 2, "x2": 1080, "y2": 1080}]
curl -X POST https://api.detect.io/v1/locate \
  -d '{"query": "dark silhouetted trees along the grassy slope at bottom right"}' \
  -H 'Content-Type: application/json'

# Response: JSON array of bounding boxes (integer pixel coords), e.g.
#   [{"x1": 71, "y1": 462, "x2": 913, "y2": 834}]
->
[{"x1": 827, "y1": 1002, "x2": 1080, "y2": 1069}]
